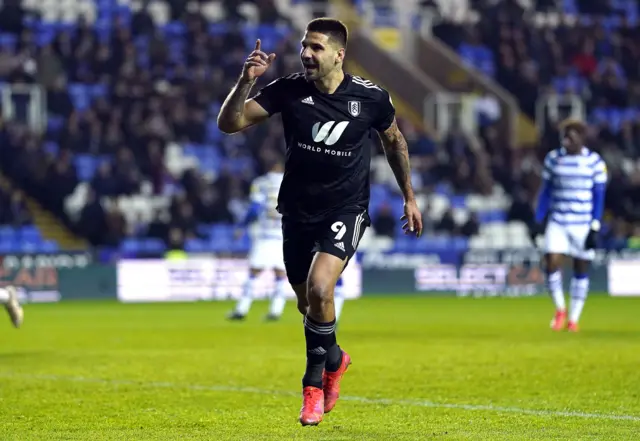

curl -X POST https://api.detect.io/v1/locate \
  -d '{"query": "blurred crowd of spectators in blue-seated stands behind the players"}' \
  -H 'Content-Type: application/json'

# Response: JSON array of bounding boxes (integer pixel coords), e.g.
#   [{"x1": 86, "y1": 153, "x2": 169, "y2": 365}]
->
[{"x1": 0, "y1": 0, "x2": 640, "y2": 253}]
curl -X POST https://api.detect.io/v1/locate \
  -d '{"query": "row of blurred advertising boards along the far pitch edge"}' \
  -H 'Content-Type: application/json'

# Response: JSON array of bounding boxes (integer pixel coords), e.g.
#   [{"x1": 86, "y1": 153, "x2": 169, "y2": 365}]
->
[{"x1": 0, "y1": 250, "x2": 640, "y2": 303}]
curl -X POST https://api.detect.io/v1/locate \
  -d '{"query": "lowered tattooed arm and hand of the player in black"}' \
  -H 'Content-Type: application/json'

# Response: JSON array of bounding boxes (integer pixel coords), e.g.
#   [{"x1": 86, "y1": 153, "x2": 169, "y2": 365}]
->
[{"x1": 378, "y1": 117, "x2": 422, "y2": 237}]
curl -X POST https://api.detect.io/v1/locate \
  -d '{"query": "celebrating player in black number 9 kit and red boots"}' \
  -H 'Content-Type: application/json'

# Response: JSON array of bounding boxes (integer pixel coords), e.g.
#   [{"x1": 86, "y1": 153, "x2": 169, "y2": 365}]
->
[{"x1": 218, "y1": 18, "x2": 422, "y2": 425}]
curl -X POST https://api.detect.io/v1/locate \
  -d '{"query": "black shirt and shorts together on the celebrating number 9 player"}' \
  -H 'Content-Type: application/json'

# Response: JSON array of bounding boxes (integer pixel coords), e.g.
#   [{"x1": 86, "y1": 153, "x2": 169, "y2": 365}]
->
[{"x1": 254, "y1": 73, "x2": 395, "y2": 285}]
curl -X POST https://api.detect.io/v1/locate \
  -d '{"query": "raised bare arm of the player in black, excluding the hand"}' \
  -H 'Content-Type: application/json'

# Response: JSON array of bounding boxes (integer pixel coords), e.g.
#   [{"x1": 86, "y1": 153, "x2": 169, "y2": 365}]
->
[{"x1": 218, "y1": 78, "x2": 269, "y2": 134}]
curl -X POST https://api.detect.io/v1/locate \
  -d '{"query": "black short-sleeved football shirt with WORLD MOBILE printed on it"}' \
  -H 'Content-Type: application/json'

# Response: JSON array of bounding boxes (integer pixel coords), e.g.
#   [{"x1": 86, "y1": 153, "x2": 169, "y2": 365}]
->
[{"x1": 254, "y1": 73, "x2": 395, "y2": 222}]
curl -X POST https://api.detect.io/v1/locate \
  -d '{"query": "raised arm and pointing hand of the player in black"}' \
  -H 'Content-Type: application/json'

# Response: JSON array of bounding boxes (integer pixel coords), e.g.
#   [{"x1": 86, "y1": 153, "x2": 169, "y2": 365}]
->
[{"x1": 218, "y1": 40, "x2": 276, "y2": 134}]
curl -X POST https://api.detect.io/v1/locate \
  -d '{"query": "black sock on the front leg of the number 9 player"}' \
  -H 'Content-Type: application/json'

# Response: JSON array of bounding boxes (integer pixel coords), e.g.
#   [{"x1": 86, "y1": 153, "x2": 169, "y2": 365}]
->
[{"x1": 302, "y1": 315, "x2": 339, "y2": 389}]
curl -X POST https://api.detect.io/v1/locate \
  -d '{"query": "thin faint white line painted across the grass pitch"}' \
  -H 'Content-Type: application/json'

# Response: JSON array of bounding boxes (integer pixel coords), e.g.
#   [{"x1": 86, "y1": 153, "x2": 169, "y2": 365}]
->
[{"x1": 0, "y1": 372, "x2": 640, "y2": 421}]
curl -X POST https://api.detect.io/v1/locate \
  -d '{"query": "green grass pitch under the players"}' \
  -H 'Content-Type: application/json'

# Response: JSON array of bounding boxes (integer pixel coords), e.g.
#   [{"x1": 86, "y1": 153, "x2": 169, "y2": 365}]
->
[{"x1": 0, "y1": 296, "x2": 640, "y2": 441}]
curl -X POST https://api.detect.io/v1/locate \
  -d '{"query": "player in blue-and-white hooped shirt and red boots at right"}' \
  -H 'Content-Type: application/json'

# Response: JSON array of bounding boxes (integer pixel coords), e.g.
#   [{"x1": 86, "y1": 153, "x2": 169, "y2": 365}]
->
[{"x1": 531, "y1": 120, "x2": 607, "y2": 332}]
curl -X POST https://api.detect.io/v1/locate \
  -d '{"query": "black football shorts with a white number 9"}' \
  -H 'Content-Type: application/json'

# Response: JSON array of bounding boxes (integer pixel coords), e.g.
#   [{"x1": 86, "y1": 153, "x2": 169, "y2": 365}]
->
[{"x1": 282, "y1": 211, "x2": 371, "y2": 285}]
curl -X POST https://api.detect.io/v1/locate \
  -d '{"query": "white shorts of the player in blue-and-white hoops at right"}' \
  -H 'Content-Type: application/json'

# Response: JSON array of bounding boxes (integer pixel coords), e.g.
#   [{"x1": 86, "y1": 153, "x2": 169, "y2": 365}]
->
[{"x1": 544, "y1": 221, "x2": 596, "y2": 260}]
